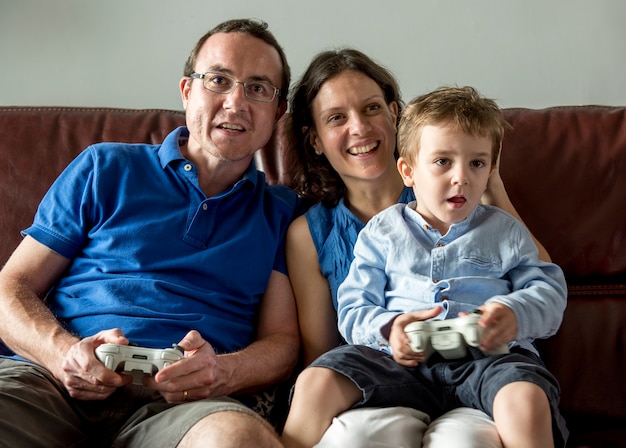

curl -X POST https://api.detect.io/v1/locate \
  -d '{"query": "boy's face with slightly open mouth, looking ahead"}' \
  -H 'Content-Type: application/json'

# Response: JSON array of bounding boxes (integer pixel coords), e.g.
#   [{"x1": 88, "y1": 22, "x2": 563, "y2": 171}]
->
[{"x1": 398, "y1": 125, "x2": 492, "y2": 235}]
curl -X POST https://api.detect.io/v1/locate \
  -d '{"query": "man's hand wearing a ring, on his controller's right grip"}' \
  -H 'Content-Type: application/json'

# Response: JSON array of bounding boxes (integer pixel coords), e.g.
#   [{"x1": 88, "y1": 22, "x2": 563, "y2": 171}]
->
[{"x1": 144, "y1": 330, "x2": 222, "y2": 403}]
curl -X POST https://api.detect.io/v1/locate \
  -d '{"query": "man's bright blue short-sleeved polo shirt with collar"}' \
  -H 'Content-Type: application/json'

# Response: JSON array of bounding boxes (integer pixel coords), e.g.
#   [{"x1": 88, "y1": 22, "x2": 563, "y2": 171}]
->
[{"x1": 23, "y1": 127, "x2": 298, "y2": 353}]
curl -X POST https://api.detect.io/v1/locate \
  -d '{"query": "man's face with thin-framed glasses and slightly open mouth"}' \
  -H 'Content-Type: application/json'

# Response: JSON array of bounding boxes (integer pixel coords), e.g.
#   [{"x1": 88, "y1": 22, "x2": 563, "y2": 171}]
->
[{"x1": 180, "y1": 32, "x2": 285, "y2": 163}]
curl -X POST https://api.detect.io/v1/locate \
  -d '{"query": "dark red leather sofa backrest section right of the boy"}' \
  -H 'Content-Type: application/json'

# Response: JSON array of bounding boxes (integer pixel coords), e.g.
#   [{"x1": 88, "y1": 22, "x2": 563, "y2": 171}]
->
[{"x1": 501, "y1": 106, "x2": 626, "y2": 284}]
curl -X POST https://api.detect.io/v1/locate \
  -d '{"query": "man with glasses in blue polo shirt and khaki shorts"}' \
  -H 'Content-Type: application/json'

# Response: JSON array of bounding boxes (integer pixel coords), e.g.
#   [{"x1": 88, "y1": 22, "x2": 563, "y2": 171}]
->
[{"x1": 0, "y1": 20, "x2": 299, "y2": 447}]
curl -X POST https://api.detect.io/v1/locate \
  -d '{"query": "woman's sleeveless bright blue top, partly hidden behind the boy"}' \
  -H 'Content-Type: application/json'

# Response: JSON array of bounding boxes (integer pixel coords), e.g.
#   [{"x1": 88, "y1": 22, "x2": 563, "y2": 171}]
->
[{"x1": 306, "y1": 187, "x2": 415, "y2": 310}]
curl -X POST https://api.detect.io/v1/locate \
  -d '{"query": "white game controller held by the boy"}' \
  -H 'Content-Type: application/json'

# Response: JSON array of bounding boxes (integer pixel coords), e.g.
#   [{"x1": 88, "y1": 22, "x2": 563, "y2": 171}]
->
[{"x1": 404, "y1": 310, "x2": 509, "y2": 359}]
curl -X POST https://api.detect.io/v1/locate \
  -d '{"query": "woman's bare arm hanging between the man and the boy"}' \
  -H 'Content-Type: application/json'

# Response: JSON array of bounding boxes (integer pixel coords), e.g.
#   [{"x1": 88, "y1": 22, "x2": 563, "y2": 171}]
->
[{"x1": 286, "y1": 216, "x2": 341, "y2": 366}]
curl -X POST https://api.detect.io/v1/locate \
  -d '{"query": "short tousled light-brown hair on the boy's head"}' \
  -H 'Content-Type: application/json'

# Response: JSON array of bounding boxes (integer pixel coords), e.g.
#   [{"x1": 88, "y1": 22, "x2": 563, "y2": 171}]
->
[{"x1": 398, "y1": 87, "x2": 511, "y2": 166}]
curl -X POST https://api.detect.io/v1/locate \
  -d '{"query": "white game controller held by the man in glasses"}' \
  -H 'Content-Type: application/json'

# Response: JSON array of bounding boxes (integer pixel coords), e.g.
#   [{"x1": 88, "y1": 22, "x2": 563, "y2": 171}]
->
[{"x1": 96, "y1": 344, "x2": 184, "y2": 384}]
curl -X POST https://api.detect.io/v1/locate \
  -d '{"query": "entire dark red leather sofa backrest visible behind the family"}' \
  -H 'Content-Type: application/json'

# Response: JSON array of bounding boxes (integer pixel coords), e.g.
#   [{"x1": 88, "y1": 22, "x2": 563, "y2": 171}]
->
[{"x1": 0, "y1": 106, "x2": 626, "y2": 284}]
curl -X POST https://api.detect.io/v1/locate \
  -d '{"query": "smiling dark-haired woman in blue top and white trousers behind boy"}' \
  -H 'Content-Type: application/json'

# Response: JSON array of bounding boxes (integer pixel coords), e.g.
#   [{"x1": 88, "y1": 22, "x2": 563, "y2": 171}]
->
[{"x1": 287, "y1": 49, "x2": 549, "y2": 447}]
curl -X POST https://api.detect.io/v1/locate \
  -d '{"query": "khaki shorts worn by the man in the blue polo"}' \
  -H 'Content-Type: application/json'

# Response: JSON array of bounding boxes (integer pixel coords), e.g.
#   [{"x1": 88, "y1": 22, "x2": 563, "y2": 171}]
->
[{"x1": 0, "y1": 357, "x2": 264, "y2": 448}]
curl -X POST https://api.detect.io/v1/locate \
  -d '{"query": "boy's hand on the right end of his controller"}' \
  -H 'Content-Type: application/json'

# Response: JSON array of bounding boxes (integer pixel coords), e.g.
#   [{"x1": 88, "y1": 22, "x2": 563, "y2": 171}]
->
[{"x1": 478, "y1": 302, "x2": 517, "y2": 351}]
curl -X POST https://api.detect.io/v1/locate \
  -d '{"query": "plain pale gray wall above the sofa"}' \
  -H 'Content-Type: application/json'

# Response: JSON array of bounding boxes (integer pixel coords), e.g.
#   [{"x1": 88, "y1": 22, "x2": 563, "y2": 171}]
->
[{"x1": 0, "y1": 0, "x2": 626, "y2": 109}]
